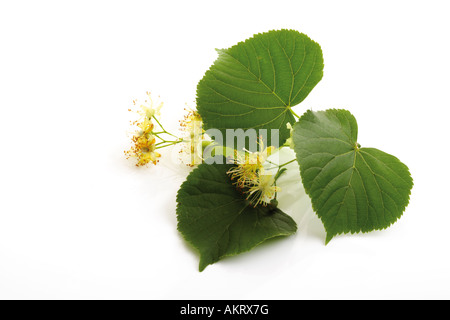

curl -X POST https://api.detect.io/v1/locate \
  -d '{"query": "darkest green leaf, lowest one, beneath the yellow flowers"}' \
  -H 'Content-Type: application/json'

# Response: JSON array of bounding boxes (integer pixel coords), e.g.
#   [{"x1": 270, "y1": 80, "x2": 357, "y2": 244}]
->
[{"x1": 177, "y1": 160, "x2": 297, "y2": 271}]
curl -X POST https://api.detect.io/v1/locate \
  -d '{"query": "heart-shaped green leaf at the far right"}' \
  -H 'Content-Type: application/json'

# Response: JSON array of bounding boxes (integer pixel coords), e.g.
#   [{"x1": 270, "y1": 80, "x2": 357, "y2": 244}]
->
[{"x1": 293, "y1": 110, "x2": 413, "y2": 243}]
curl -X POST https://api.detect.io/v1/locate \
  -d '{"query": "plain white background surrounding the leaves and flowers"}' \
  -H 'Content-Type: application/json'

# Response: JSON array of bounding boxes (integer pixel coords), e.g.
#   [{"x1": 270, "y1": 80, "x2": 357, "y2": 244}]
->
[{"x1": 0, "y1": 0, "x2": 450, "y2": 299}]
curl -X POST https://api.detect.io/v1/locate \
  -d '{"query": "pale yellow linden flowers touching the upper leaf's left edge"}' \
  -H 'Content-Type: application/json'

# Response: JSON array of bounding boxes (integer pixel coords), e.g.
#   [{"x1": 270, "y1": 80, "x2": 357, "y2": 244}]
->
[{"x1": 180, "y1": 109, "x2": 204, "y2": 167}]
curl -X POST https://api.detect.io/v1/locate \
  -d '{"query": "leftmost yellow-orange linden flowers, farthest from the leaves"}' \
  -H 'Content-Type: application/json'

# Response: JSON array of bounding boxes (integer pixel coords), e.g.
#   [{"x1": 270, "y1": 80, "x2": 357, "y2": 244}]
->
[{"x1": 125, "y1": 92, "x2": 163, "y2": 167}]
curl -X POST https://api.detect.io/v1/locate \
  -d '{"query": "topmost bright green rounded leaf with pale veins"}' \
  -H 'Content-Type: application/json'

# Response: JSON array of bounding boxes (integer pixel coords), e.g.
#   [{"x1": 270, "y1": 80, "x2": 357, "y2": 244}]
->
[{"x1": 197, "y1": 30, "x2": 323, "y2": 148}]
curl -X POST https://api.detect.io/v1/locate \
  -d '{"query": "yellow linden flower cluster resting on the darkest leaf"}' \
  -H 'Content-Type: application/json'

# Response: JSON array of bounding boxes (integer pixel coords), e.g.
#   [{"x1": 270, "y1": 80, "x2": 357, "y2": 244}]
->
[{"x1": 227, "y1": 139, "x2": 280, "y2": 207}]
